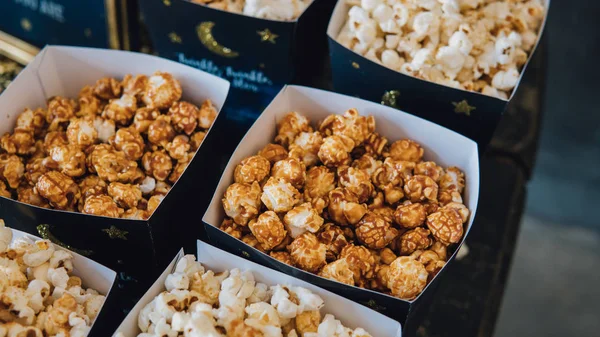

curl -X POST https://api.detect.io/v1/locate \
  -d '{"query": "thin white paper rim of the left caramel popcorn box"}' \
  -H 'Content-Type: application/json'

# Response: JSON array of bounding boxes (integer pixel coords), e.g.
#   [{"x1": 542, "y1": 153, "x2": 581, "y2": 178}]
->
[{"x1": 0, "y1": 45, "x2": 231, "y2": 223}]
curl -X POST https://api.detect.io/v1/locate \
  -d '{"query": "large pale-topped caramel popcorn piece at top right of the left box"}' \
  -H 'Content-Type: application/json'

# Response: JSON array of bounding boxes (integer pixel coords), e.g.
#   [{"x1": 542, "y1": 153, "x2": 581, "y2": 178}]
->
[{"x1": 142, "y1": 72, "x2": 182, "y2": 109}]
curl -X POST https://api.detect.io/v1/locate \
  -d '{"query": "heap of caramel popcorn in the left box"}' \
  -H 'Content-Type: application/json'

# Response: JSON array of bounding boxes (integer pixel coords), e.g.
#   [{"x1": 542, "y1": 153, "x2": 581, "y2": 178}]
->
[{"x1": 0, "y1": 72, "x2": 216, "y2": 219}]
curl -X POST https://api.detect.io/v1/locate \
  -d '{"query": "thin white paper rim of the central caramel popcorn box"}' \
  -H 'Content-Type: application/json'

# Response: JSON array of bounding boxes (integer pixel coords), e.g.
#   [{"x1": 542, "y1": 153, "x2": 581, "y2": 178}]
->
[{"x1": 202, "y1": 85, "x2": 480, "y2": 304}]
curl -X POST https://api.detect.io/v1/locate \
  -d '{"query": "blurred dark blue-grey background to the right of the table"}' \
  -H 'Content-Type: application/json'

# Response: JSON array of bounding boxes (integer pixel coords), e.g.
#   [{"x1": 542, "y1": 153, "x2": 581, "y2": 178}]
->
[{"x1": 495, "y1": 0, "x2": 600, "y2": 337}]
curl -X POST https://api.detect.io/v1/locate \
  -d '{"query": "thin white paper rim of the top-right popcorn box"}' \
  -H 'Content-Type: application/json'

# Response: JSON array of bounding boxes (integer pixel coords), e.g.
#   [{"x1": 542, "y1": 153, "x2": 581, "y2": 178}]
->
[{"x1": 327, "y1": 0, "x2": 550, "y2": 104}]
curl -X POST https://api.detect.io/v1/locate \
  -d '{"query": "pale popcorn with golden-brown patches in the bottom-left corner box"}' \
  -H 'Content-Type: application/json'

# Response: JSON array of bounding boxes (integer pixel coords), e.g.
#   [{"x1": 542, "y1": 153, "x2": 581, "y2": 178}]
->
[{"x1": 0, "y1": 219, "x2": 105, "y2": 337}]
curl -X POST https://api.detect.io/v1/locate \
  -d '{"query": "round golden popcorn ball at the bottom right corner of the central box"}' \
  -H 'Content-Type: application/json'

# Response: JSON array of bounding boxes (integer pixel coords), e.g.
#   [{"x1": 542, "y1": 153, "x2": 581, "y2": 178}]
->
[{"x1": 387, "y1": 256, "x2": 429, "y2": 300}]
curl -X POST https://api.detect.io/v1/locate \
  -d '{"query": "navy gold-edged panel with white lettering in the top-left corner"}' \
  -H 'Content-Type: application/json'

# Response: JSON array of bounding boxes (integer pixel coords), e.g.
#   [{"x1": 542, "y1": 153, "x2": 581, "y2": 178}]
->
[{"x1": 0, "y1": 0, "x2": 129, "y2": 49}]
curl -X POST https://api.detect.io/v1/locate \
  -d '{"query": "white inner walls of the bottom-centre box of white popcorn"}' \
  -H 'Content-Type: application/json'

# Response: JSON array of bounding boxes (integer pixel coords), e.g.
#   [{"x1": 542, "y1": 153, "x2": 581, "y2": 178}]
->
[{"x1": 115, "y1": 241, "x2": 402, "y2": 337}]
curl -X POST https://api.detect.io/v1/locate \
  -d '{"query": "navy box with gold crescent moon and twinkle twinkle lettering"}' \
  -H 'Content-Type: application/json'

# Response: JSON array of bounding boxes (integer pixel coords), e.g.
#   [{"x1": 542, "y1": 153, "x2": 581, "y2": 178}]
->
[{"x1": 140, "y1": 0, "x2": 334, "y2": 124}]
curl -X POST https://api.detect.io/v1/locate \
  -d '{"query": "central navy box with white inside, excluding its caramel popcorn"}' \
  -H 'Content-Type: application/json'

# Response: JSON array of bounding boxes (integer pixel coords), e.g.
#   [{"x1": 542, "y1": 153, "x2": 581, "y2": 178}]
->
[{"x1": 202, "y1": 86, "x2": 479, "y2": 332}]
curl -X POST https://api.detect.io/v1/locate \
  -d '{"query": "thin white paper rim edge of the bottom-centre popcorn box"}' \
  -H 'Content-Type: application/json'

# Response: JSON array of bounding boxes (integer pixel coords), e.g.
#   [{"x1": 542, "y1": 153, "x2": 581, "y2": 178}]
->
[{"x1": 113, "y1": 240, "x2": 402, "y2": 337}]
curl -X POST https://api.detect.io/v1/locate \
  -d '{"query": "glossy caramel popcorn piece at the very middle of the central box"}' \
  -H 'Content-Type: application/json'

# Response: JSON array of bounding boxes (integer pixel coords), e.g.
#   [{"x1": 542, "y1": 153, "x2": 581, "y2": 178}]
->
[{"x1": 328, "y1": 188, "x2": 367, "y2": 226}]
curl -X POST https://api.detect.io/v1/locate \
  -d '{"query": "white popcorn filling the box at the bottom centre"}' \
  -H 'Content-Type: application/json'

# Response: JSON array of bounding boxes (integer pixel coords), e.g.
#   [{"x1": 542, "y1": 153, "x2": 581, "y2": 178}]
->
[{"x1": 118, "y1": 255, "x2": 380, "y2": 337}]
